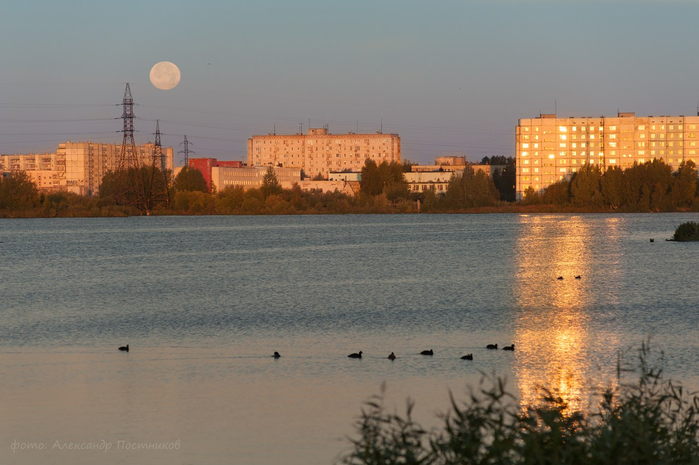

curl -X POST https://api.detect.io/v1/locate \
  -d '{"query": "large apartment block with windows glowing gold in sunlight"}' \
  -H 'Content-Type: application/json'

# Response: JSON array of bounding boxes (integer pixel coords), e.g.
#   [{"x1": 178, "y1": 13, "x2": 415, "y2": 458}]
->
[{"x1": 515, "y1": 113, "x2": 699, "y2": 199}]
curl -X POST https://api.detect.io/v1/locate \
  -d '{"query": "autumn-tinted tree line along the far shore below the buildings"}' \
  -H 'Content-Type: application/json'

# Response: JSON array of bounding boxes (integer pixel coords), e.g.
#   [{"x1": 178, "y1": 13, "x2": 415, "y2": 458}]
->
[{"x1": 0, "y1": 157, "x2": 699, "y2": 217}]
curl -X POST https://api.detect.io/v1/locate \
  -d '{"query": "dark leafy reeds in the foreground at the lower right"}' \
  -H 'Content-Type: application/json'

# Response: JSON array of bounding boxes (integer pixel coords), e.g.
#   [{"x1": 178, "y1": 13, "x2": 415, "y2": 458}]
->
[{"x1": 341, "y1": 345, "x2": 699, "y2": 465}]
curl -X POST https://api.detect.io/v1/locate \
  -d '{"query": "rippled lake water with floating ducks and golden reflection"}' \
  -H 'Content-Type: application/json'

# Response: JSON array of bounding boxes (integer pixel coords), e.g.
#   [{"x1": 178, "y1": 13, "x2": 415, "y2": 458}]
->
[{"x1": 0, "y1": 214, "x2": 699, "y2": 465}]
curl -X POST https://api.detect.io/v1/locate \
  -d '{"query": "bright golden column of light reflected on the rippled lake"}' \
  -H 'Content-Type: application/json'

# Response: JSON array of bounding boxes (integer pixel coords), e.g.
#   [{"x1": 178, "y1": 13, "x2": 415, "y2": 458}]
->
[{"x1": 515, "y1": 215, "x2": 617, "y2": 410}]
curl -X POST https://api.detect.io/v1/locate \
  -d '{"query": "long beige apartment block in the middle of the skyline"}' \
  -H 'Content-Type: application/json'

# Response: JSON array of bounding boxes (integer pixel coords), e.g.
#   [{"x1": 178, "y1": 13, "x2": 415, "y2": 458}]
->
[{"x1": 248, "y1": 128, "x2": 400, "y2": 177}]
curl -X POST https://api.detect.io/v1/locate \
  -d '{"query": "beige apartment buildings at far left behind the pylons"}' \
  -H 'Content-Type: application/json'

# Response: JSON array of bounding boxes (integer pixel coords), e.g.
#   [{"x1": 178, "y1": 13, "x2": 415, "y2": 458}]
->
[{"x1": 0, "y1": 141, "x2": 173, "y2": 195}]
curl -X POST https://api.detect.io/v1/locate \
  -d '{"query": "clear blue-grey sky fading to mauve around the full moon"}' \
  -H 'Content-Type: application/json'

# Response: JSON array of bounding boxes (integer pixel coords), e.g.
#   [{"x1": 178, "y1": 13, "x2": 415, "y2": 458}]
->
[{"x1": 0, "y1": 0, "x2": 699, "y2": 163}]
